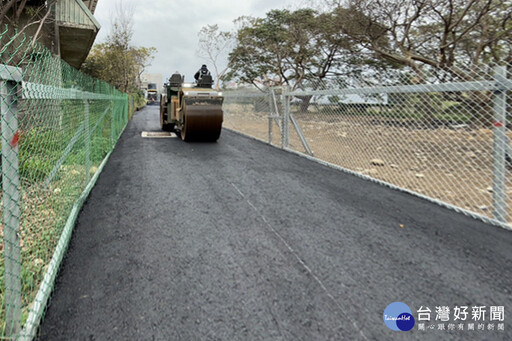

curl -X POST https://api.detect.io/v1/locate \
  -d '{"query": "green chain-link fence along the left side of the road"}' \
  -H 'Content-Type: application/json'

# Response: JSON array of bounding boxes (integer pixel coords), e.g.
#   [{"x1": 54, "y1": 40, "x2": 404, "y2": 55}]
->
[{"x1": 0, "y1": 28, "x2": 134, "y2": 339}]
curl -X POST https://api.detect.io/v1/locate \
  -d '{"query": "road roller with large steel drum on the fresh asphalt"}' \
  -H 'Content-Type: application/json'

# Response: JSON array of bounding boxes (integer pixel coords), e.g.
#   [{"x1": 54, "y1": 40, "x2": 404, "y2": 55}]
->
[{"x1": 160, "y1": 73, "x2": 223, "y2": 142}]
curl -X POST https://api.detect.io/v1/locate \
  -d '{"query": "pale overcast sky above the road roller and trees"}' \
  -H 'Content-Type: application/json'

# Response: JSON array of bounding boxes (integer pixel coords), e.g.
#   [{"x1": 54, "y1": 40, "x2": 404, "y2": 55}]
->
[{"x1": 94, "y1": 0, "x2": 302, "y2": 82}]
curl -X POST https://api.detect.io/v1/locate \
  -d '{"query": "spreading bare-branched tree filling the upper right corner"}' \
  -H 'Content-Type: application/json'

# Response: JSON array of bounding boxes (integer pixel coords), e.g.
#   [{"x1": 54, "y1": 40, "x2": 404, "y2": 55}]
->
[{"x1": 335, "y1": 0, "x2": 512, "y2": 79}]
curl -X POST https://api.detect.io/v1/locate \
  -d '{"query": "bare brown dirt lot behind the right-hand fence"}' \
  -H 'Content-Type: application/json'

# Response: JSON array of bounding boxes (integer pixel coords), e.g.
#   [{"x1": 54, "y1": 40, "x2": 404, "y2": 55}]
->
[{"x1": 224, "y1": 104, "x2": 512, "y2": 223}]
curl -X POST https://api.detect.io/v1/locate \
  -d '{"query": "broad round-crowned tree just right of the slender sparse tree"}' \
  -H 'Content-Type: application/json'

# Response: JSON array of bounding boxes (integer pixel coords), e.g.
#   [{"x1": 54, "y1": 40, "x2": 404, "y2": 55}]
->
[{"x1": 229, "y1": 9, "x2": 352, "y2": 89}]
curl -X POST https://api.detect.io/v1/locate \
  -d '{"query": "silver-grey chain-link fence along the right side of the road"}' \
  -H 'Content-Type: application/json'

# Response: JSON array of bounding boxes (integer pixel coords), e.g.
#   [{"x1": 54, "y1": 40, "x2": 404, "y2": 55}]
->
[{"x1": 224, "y1": 65, "x2": 512, "y2": 228}]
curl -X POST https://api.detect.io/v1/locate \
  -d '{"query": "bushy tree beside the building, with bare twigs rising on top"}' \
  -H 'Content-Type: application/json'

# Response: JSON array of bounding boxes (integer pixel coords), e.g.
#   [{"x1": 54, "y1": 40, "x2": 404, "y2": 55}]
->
[{"x1": 82, "y1": 3, "x2": 156, "y2": 92}]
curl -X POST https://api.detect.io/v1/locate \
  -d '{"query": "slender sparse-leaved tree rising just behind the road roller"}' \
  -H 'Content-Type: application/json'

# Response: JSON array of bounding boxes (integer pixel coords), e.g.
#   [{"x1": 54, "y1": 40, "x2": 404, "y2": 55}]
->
[{"x1": 197, "y1": 25, "x2": 234, "y2": 90}]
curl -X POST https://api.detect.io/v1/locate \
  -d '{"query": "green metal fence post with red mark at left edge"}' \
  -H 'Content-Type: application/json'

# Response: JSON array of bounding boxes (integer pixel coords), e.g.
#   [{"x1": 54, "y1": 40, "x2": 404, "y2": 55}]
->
[{"x1": 0, "y1": 66, "x2": 21, "y2": 338}]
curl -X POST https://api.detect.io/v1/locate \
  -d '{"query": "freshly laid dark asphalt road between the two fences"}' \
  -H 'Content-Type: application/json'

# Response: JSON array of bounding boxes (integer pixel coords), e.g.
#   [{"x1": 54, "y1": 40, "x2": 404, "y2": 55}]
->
[{"x1": 39, "y1": 107, "x2": 512, "y2": 340}]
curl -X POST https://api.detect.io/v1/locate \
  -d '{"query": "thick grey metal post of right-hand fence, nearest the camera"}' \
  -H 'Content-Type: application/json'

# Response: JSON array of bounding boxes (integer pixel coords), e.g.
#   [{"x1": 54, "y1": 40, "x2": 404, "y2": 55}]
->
[{"x1": 492, "y1": 66, "x2": 508, "y2": 222}]
